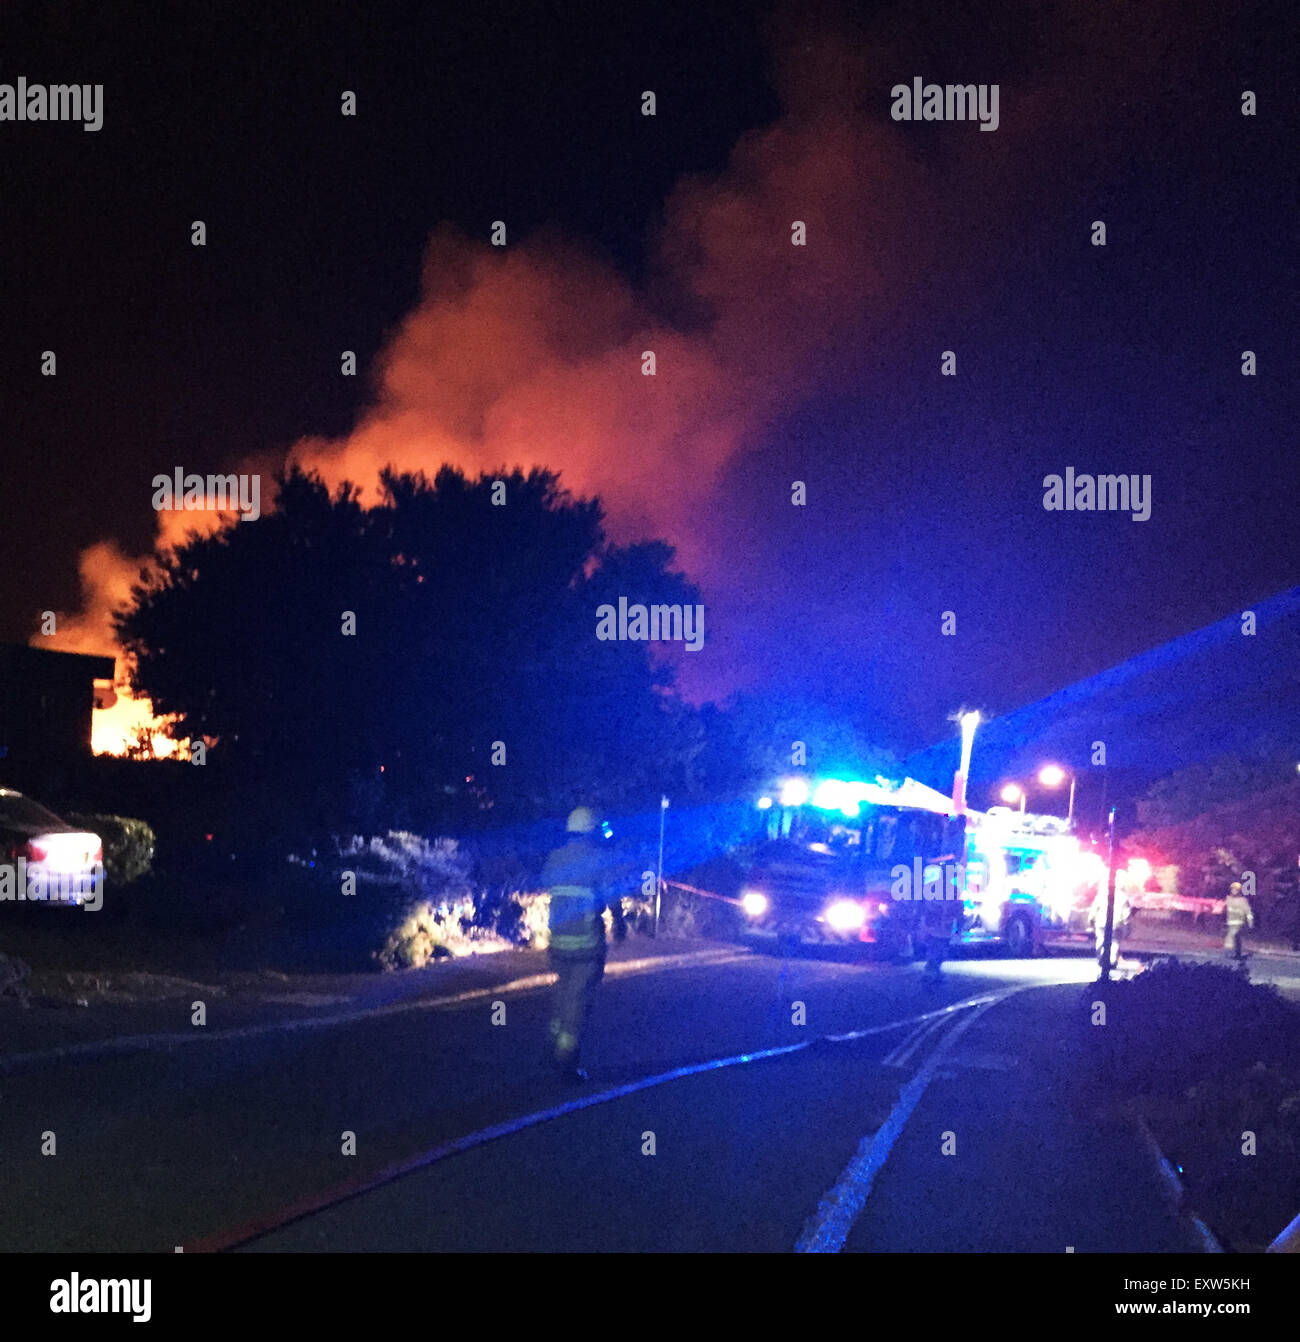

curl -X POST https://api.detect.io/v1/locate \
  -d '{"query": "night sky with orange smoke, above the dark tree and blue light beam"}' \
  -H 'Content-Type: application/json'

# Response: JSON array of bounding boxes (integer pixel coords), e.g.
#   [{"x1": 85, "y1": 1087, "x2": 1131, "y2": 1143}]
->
[{"x1": 0, "y1": 3, "x2": 1300, "y2": 749}]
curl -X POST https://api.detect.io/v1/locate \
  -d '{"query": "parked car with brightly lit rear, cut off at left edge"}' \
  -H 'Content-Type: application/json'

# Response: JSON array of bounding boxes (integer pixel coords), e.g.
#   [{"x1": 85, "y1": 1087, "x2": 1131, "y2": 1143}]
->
[{"x1": 0, "y1": 788, "x2": 103, "y2": 909}]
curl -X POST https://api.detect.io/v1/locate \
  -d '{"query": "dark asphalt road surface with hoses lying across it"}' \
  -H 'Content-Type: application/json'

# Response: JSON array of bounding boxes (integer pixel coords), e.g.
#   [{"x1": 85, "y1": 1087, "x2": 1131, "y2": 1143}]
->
[{"x1": 0, "y1": 946, "x2": 1287, "y2": 1252}]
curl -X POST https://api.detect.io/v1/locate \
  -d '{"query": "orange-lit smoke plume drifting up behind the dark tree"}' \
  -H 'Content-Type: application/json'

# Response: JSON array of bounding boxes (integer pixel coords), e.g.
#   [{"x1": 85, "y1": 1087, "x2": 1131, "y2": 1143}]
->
[{"x1": 51, "y1": 5, "x2": 1185, "y2": 742}]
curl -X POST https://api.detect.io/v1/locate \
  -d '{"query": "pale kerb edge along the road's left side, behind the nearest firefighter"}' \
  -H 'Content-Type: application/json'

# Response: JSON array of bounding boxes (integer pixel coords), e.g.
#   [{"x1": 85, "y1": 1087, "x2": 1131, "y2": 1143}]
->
[{"x1": 0, "y1": 950, "x2": 753, "y2": 1076}]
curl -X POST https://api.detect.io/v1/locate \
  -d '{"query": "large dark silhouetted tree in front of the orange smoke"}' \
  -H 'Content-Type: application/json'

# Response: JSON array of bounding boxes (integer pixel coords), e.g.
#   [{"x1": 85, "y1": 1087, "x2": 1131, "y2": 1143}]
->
[{"x1": 117, "y1": 467, "x2": 699, "y2": 832}]
